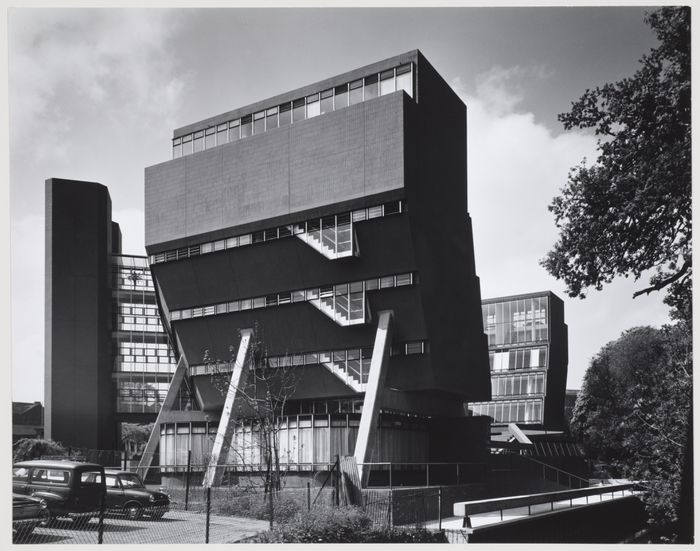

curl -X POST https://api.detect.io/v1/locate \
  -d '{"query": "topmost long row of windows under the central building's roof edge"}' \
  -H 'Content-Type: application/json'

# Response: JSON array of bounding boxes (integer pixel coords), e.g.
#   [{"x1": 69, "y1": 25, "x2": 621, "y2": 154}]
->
[{"x1": 173, "y1": 63, "x2": 413, "y2": 159}]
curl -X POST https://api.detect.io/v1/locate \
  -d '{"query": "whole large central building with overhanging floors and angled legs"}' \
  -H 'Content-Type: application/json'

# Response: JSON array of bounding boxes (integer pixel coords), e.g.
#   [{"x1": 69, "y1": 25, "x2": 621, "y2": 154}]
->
[{"x1": 143, "y1": 51, "x2": 490, "y2": 482}]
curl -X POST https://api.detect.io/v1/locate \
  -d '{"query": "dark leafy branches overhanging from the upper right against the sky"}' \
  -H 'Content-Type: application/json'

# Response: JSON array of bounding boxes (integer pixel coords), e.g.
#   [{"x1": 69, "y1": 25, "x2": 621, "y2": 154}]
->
[{"x1": 542, "y1": 7, "x2": 692, "y2": 320}]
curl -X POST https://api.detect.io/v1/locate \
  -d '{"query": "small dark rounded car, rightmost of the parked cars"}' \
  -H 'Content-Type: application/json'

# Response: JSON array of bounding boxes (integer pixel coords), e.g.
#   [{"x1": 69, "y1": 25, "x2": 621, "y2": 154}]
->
[{"x1": 105, "y1": 469, "x2": 170, "y2": 519}]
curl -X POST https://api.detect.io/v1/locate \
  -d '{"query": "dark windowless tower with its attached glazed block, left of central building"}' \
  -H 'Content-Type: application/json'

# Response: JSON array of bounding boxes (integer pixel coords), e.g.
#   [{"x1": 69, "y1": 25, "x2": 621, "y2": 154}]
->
[{"x1": 44, "y1": 178, "x2": 174, "y2": 450}]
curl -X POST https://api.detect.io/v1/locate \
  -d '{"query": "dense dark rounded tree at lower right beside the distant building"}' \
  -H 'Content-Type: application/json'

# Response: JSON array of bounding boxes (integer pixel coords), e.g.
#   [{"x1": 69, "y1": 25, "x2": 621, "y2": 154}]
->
[{"x1": 572, "y1": 323, "x2": 692, "y2": 536}]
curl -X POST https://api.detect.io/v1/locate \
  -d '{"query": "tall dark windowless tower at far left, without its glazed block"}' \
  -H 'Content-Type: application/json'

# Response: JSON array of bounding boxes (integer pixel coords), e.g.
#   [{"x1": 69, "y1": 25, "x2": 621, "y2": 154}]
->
[{"x1": 44, "y1": 178, "x2": 117, "y2": 450}]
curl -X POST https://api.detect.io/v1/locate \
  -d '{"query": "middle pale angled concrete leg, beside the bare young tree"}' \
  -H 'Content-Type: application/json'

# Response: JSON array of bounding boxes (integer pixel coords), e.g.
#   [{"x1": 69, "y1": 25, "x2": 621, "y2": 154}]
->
[{"x1": 202, "y1": 329, "x2": 253, "y2": 488}]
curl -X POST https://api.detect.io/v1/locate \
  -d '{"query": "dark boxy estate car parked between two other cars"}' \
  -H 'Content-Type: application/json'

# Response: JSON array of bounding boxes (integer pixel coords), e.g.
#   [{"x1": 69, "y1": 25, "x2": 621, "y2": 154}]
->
[{"x1": 12, "y1": 460, "x2": 106, "y2": 521}]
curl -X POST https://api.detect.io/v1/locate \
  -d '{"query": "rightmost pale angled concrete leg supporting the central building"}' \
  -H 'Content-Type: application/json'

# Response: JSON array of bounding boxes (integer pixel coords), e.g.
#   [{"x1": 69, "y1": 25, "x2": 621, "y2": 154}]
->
[{"x1": 355, "y1": 310, "x2": 393, "y2": 488}]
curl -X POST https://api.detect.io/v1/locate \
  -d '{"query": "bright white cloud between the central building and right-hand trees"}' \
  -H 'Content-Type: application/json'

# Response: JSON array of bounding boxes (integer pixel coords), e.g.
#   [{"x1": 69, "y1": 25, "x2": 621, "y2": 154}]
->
[{"x1": 452, "y1": 67, "x2": 668, "y2": 388}]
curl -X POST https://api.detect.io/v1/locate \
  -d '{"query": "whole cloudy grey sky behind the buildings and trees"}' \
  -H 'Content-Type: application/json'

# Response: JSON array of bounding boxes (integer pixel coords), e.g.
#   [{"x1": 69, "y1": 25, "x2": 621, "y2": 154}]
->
[{"x1": 8, "y1": 7, "x2": 669, "y2": 401}]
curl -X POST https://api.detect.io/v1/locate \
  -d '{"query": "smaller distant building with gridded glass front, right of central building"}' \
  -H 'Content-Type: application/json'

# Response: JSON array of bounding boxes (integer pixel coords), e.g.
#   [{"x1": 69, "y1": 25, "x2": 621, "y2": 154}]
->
[{"x1": 469, "y1": 291, "x2": 568, "y2": 430}]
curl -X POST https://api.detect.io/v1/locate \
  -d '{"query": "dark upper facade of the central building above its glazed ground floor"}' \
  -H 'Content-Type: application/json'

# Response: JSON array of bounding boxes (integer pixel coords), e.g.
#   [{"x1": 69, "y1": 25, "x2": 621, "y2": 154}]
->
[{"x1": 145, "y1": 51, "x2": 490, "y2": 474}]
